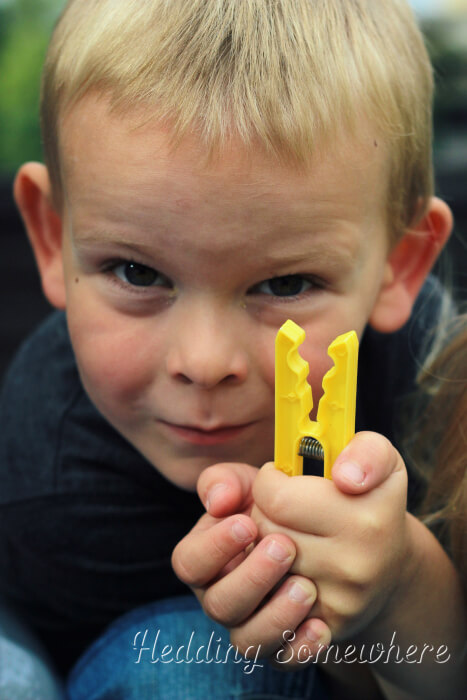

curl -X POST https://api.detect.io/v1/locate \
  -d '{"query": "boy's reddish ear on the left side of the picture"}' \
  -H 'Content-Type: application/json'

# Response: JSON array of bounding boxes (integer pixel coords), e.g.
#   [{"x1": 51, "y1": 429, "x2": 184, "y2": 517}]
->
[{"x1": 13, "y1": 163, "x2": 66, "y2": 309}]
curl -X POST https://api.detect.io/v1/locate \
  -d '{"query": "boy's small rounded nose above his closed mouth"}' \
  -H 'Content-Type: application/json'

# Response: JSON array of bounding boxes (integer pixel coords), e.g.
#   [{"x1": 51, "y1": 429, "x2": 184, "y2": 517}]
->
[{"x1": 166, "y1": 308, "x2": 248, "y2": 389}]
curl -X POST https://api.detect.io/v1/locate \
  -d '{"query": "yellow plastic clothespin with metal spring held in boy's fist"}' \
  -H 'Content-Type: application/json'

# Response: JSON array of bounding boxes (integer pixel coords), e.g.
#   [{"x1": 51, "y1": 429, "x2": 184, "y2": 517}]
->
[{"x1": 274, "y1": 321, "x2": 358, "y2": 479}]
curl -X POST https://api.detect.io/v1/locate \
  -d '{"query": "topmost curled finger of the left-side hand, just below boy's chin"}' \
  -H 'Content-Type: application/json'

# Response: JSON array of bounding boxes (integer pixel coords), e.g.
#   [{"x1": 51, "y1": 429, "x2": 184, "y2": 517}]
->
[{"x1": 197, "y1": 463, "x2": 258, "y2": 518}]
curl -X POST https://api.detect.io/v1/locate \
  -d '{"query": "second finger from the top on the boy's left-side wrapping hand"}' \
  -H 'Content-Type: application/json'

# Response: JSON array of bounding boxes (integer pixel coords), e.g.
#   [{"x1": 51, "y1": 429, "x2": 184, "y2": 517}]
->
[{"x1": 172, "y1": 514, "x2": 257, "y2": 587}]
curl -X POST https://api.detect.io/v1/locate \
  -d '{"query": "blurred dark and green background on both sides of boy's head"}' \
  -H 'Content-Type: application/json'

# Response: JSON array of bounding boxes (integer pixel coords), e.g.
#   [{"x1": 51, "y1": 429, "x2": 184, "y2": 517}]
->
[{"x1": 0, "y1": 0, "x2": 467, "y2": 378}]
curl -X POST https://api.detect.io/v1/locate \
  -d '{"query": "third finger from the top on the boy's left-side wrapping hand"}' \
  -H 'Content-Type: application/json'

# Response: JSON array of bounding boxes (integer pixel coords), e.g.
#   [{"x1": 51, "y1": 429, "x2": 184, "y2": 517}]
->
[{"x1": 203, "y1": 534, "x2": 295, "y2": 628}]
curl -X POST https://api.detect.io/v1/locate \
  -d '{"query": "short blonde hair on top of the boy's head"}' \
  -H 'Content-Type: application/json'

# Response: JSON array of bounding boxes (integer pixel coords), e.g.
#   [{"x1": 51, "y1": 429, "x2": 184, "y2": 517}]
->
[{"x1": 41, "y1": 0, "x2": 432, "y2": 237}]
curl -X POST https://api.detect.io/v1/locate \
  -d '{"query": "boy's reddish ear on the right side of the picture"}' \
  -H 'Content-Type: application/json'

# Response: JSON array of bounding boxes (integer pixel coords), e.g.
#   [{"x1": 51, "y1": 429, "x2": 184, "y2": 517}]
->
[{"x1": 369, "y1": 197, "x2": 453, "y2": 333}]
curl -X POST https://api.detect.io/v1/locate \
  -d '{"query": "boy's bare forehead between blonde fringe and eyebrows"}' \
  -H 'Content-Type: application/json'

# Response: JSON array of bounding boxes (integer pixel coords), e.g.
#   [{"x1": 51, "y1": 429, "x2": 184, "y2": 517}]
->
[{"x1": 60, "y1": 96, "x2": 388, "y2": 245}]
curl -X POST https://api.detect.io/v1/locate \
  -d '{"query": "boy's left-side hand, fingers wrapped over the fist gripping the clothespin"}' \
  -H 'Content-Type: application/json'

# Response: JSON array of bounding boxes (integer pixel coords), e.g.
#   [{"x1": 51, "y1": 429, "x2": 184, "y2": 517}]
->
[{"x1": 172, "y1": 464, "x2": 330, "y2": 663}]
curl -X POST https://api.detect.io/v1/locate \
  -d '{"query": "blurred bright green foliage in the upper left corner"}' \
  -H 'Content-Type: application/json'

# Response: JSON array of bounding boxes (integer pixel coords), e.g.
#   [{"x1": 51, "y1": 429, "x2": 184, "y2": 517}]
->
[{"x1": 0, "y1": 0, "x2": 64, "y2": 175}]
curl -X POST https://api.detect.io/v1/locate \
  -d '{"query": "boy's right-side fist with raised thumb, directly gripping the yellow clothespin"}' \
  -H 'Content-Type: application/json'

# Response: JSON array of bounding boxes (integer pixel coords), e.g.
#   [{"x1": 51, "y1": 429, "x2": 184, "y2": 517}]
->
[{"x1": 251, "y1": 433, "x2": 411, "y2": 639}]
